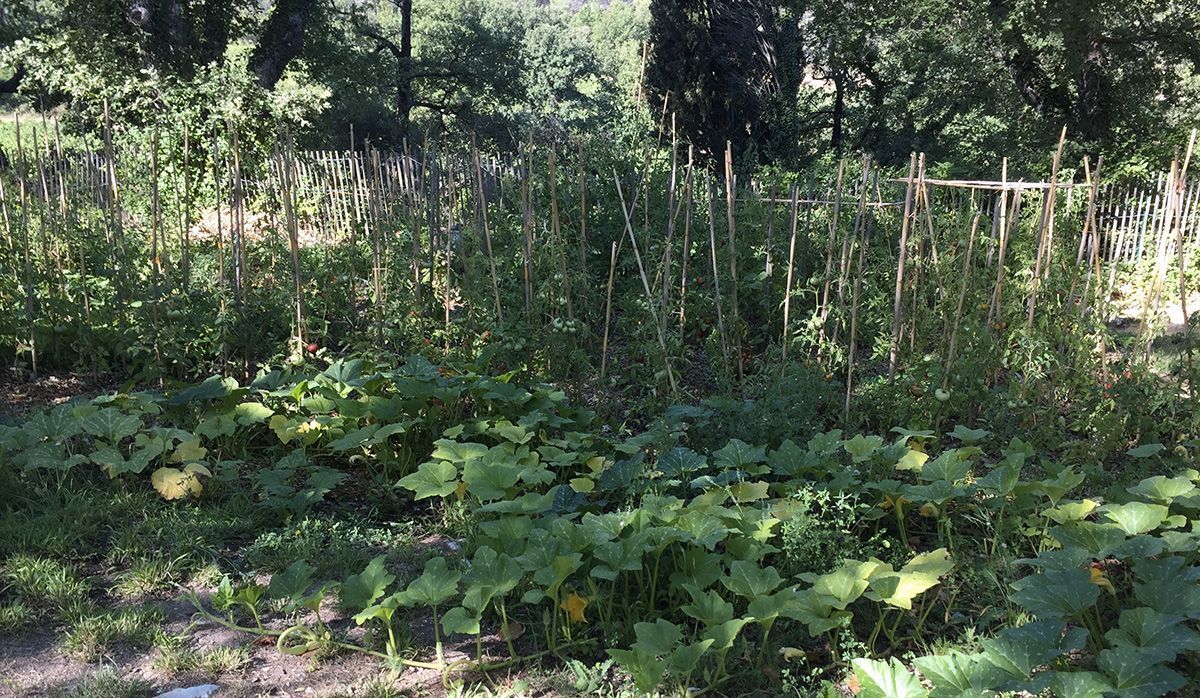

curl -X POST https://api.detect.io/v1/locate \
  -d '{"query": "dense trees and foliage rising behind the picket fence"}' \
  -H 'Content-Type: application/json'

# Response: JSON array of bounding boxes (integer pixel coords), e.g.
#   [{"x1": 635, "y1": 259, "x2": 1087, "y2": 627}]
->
[{"x1": 0, "y1": 0, "x2": 1200, "y2": 176}]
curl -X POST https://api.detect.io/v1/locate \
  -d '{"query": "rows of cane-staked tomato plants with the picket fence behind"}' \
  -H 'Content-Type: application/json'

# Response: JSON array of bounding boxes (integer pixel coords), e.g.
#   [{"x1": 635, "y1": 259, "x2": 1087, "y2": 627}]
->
[{"x1": 0, "y1": 112, "x2": 1200, "y2": 424}]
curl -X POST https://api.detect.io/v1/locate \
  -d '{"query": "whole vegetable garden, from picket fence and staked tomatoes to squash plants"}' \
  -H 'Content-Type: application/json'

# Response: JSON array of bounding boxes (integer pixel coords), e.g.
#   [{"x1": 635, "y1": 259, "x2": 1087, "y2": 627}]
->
[{"x1": 0, "y1": 113, "x2": 1200, "y2": 698}]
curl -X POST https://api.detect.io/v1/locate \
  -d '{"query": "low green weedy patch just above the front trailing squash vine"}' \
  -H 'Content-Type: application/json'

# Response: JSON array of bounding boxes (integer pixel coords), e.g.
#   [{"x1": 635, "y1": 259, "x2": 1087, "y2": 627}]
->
[{"x1": 242, "y1": 517, "x2": 416, "y2": 578}]
